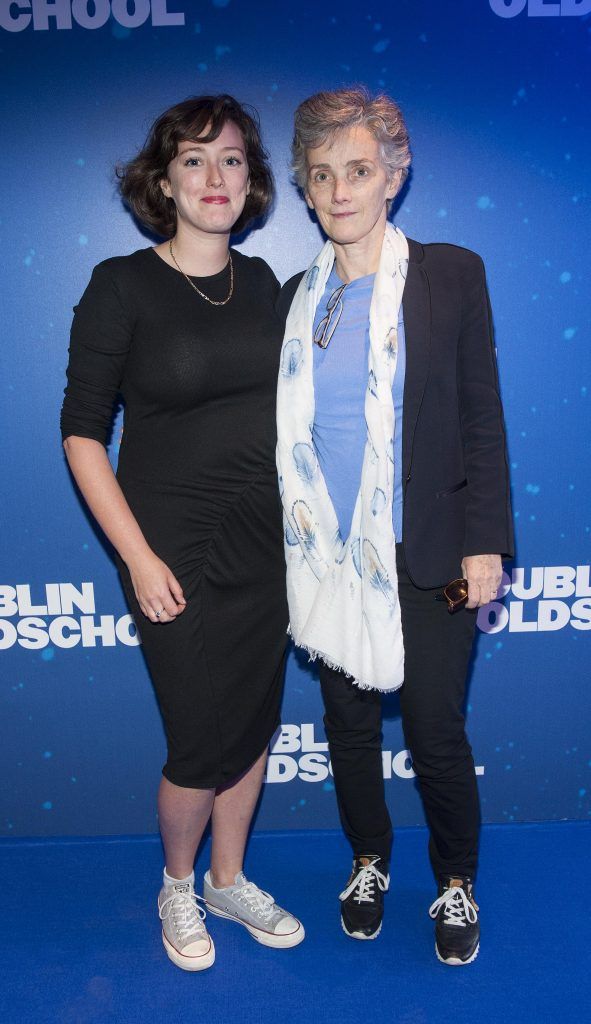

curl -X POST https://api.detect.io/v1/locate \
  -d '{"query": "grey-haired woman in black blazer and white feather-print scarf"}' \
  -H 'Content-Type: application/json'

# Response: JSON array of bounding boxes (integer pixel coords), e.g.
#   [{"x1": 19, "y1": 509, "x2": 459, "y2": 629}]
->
[{"x1": 278, "y1": 89, "x2": 512, "y2": 965}]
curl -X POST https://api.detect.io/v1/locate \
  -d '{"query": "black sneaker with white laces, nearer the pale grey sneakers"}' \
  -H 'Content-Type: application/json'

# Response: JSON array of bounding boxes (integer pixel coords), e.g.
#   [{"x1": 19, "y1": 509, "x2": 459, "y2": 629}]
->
[{"x1": 339, "y1": 853, "x2": 390, "y2": 939}]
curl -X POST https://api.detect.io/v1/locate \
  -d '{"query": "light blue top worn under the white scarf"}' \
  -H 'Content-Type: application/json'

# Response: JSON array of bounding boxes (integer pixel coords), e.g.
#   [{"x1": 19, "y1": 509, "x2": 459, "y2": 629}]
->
[{"x1": 312, "y1": 267, "x2": 406, "y2": 541}]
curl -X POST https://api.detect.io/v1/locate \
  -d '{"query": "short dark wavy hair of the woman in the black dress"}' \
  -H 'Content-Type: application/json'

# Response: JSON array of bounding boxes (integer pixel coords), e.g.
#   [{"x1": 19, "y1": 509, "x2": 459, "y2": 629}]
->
[{"x1": 116, "y1": 93, "x2": 275, "y2": 239}]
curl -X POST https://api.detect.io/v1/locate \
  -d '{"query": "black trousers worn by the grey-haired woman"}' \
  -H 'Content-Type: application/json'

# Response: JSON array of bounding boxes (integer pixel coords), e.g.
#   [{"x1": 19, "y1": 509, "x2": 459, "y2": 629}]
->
[{"x1": 319, "y1": 545, "x2": 480, "y2": 879}]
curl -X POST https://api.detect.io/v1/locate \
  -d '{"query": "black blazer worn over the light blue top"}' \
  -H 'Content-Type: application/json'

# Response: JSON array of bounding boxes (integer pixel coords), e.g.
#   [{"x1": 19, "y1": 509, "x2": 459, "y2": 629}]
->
[{"x1": 279, "y1": 239, "x2": 513, "y2": 588}]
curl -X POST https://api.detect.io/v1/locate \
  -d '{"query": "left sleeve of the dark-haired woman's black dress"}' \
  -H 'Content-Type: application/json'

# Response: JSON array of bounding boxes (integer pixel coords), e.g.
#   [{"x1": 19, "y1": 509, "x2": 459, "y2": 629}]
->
[{"x1": 60, "y1": 261, "x2": 133, "y2": 444}]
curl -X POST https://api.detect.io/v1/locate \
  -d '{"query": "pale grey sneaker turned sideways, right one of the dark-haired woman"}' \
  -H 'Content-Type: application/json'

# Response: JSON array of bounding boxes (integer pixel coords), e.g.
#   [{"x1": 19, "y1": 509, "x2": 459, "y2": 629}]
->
[{"x1": 203, "y1": 871, "x2": 305, "y2": 949}]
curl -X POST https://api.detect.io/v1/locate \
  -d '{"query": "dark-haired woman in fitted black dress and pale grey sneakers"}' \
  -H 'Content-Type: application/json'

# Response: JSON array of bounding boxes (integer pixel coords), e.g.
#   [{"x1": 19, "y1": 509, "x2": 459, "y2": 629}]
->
[{"x1": 61, "y1": 95, "x2": 304, "y2": 971}]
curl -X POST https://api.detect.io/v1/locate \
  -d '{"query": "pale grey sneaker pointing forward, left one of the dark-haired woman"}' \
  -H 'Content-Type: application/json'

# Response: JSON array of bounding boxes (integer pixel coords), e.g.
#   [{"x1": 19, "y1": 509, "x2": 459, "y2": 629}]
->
[{"x1": 158, "y1": 882, "x2": 215, "y2": 971}]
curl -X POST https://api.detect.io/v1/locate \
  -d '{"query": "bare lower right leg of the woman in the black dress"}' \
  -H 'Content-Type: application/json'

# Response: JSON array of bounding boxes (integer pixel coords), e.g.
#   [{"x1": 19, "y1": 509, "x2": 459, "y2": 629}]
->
[{"x1": 211, "y1": 750, "x2": 267, "y2": 889}]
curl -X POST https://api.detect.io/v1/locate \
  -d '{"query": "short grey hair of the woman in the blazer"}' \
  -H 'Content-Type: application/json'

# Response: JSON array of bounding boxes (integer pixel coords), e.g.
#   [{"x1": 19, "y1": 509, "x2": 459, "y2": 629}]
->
[{"x1": 292, "y1": 86, "x2": 411, "y2": 191}]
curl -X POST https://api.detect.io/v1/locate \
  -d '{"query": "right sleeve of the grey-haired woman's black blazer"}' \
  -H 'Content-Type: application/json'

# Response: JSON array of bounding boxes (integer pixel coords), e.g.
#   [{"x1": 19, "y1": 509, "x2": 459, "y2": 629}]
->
[{"x1": 458, "y1": 254, "x2": 513, "y2": 557}]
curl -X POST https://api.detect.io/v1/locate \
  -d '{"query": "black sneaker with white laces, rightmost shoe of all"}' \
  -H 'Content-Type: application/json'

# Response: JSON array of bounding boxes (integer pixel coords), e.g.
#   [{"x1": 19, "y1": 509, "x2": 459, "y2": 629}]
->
[{"x1": 429, "y1": 878, "x2": 480, "y2": 967}]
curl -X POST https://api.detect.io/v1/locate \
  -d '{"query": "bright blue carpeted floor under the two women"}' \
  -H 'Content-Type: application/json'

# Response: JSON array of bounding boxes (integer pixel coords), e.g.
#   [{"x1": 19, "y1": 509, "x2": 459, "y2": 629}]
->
[{"x1": 0, "y1": 822, "x2": 591, "y2": 1024}]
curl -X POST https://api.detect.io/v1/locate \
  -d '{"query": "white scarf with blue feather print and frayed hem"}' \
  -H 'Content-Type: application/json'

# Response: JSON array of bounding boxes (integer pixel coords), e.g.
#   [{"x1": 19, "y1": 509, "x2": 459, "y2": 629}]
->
[{"x1": 277, "y1": 224, "x2": 409, "y2": 691}]
